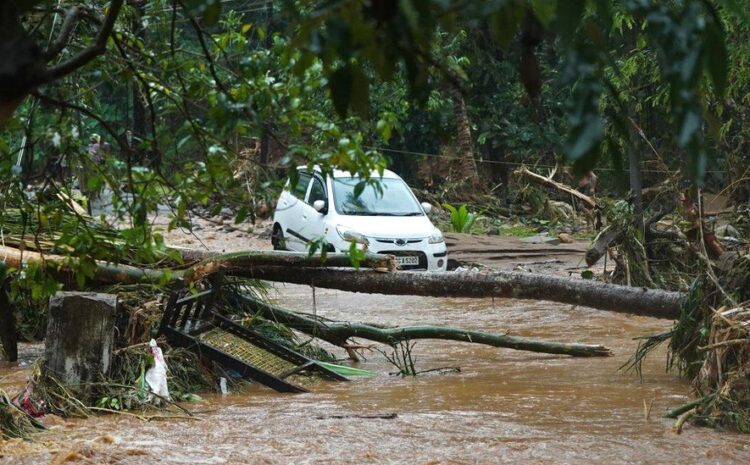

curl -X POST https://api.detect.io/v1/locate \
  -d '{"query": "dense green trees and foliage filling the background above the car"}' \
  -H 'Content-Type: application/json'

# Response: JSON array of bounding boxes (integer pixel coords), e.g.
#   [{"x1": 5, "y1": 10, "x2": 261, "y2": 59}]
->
[{"x1": 0, "y1": 0, "x2": 750, "y2": 427}]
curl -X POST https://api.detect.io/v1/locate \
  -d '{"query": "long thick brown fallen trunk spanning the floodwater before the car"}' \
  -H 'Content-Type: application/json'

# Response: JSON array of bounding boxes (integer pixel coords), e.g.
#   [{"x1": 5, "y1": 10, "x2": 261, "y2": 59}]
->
[{"x1": 235, "y1": 266, "x2": 685, "y2": 319}]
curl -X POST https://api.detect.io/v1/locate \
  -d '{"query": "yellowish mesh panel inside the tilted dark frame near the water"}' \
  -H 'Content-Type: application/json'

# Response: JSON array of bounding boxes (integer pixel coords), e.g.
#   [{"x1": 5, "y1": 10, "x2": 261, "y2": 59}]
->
[{"x1": 200, "y1": 328, "x2": 297, "y2": 377}]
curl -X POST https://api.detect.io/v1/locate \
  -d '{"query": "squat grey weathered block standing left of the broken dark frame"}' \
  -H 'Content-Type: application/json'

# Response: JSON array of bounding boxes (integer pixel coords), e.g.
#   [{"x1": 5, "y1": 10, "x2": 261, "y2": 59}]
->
[{"x1": 44, "y1": 292, "x2": 117, "y2": 385}]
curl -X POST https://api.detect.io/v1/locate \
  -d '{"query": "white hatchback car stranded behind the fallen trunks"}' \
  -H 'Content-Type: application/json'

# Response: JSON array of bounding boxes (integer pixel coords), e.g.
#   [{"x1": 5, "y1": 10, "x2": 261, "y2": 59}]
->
[{"x1": 271, "y1": 167, "x2": 448, "y2": 271}]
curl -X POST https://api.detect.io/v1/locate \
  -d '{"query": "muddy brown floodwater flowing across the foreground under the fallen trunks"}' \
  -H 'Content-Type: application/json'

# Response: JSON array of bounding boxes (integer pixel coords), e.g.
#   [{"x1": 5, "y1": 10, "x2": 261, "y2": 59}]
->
[{"x1": 0, "y1": 285, "x2": 750, "y2": 464}]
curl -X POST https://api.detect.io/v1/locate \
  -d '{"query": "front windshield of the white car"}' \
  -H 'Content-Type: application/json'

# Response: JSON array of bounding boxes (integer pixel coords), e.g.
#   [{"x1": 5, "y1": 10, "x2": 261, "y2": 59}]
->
[{"x1": 333, "y1": 178, "x2": 423, "y2": 216}]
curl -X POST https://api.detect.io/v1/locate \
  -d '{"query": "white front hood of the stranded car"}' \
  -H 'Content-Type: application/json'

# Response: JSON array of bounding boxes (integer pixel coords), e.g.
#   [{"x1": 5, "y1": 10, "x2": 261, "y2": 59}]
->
[{"x1": 337, "y1": 216, "x2": 435, "y2": 239}]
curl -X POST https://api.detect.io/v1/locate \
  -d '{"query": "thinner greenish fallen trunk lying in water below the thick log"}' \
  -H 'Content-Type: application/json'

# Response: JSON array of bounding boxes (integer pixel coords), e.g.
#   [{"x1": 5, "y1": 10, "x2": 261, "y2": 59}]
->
[{"x1": 231, "y1": 294, "x2": 612, "y2": 357}]
